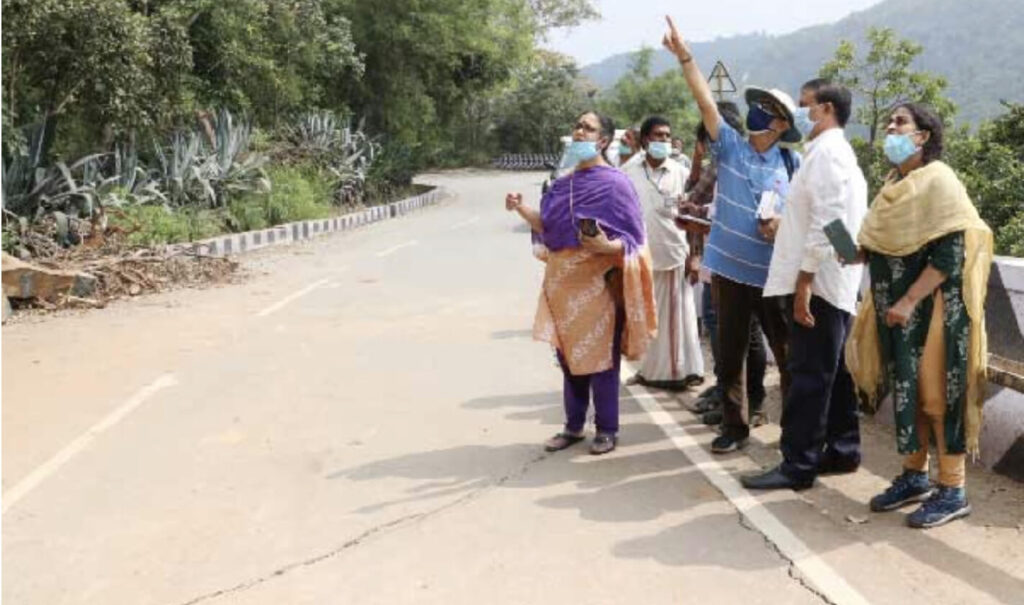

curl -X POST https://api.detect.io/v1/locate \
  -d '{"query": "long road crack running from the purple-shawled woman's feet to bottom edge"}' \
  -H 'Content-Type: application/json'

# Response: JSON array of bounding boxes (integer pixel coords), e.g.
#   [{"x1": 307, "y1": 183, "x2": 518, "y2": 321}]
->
[{"x1": 182, "y1": 452, "x2": 551, "y2": 605}]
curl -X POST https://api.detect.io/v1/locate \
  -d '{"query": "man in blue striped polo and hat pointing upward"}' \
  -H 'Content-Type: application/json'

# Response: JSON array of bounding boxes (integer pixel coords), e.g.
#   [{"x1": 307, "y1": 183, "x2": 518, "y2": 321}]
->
[{"x1": 664, "y1": 13, "x2": 801, "y2": 453}]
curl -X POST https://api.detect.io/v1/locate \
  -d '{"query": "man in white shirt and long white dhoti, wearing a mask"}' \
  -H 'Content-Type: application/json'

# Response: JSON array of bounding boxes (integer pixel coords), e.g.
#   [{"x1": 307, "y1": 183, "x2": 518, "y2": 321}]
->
[{"x1": 621, "y1": 117, "x2": 703, "y2": 390}]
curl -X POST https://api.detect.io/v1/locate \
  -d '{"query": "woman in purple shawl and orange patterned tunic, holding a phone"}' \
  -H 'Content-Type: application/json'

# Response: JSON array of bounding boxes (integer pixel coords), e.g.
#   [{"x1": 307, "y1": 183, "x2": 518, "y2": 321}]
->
[{"x1": 505, "y1": 112, "x2": 657, "y2": 455}]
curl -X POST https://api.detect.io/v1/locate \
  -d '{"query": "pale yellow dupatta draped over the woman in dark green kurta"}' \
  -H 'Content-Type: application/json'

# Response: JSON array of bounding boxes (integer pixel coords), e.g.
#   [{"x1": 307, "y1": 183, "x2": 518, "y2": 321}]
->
[{"x1": 846, "y1": 162, "x2": 992, "y2": 455}]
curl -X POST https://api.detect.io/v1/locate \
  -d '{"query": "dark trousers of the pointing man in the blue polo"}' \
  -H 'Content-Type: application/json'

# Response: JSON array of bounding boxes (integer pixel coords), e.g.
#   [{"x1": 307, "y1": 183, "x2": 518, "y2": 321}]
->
[{"x1": 711, "y1": 275, "x2": 790, "y2": 439}]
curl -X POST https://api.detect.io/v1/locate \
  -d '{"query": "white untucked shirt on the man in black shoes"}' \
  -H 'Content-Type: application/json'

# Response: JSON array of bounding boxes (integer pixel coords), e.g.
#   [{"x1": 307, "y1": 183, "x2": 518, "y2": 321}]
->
[{"x1": 764, "y1": 128, "x2": 867, "y2": 314}]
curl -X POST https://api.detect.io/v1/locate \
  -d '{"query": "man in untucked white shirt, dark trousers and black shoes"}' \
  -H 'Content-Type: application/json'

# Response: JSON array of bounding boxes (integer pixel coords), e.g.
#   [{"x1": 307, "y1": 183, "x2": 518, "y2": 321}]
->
[{"x1": 741, "y1": 79, "x2": 867, "y2": 489}]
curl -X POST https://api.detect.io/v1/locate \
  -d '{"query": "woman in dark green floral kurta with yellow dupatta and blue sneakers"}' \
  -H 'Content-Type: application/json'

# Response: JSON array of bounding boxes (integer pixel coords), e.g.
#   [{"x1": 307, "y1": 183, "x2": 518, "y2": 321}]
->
[{"x1": 847, "y1": 103, "x2": 992, "y2": 528}]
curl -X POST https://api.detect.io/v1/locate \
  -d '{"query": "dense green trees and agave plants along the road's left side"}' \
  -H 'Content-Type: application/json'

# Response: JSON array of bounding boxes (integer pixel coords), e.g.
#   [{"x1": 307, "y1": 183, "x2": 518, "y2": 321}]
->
[{"x1": 2, "y1": 0, "x2": 596, "y2": 248}]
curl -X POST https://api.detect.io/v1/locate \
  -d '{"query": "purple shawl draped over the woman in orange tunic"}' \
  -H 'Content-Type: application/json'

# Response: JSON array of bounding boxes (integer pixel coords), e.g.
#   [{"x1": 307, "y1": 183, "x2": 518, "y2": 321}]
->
[{"x1": 534, "y1": 166, "x2": 646, "y2": 256}]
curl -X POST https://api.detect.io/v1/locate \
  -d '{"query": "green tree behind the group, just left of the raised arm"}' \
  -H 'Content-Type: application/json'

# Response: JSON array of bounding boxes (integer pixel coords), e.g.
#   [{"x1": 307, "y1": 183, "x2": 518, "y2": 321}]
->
[{"x1": 600, "y1": 48, "x2": 697, "y2": 142}]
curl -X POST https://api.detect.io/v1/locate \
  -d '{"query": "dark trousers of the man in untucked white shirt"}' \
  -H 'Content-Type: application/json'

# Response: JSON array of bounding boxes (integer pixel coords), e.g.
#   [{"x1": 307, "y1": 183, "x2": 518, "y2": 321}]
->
[{"x1": 780, "y1": 296, "x2": 860, "y2": 480}]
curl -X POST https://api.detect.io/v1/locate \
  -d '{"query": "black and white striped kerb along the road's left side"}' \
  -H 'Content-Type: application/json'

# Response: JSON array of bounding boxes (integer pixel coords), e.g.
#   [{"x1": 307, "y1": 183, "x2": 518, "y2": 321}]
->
[{"x1": 176, "y1": 188, "x2": 444, "y2": 256}]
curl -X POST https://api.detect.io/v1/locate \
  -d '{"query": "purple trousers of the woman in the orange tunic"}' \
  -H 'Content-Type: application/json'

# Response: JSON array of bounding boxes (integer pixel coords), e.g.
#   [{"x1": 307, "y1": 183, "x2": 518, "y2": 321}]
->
[{"x1": 558, "y1": 310, "x2": 626, "y2": 435}]
